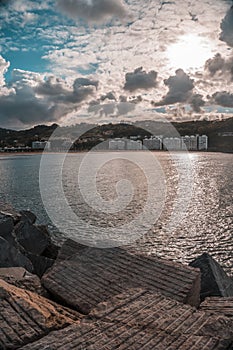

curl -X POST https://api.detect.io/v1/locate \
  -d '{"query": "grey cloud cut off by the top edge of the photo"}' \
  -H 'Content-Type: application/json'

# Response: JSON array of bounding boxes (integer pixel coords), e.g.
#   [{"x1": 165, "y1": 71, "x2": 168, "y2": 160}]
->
[{"x1": 57, "y1": 0, "x2": 125, "y2": 22}]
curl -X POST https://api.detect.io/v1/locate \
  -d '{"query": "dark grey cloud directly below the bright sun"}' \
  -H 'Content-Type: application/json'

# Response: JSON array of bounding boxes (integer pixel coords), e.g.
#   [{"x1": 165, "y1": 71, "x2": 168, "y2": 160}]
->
[{"x1": 154, "y1": 69, "x2": 194, "y2": 106}]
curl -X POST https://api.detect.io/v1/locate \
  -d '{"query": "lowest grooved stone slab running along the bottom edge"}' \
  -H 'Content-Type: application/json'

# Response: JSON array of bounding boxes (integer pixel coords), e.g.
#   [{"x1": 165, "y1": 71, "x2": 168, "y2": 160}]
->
[{"x1": 20, "y1": 322, "x2": 232, "y2": 350}]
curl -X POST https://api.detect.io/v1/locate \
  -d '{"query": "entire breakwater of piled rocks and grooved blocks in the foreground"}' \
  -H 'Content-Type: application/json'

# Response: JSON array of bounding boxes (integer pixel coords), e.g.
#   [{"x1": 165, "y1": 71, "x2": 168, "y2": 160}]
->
[{"x1": 0, "y1": 204, "x2": 233, "y2": 350}]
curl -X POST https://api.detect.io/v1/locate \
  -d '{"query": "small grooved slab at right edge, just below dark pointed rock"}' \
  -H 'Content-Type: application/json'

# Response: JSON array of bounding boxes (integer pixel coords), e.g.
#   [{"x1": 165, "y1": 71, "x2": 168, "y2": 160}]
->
[{"x1": 200, "y1": 297, "x2": 233, "y2": 318}]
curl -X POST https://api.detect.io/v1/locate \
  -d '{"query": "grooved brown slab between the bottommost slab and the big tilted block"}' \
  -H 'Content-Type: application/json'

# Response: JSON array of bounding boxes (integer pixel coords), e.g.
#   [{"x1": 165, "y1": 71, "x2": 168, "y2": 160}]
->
[{"x1": 88, "y1": 289, "x2": 233, "y2": 340}]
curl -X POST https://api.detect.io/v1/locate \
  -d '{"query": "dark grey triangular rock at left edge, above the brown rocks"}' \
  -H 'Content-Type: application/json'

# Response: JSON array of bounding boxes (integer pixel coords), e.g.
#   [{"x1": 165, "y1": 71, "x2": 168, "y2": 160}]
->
[{"x1": 0, "y1": 237, "x2": 33, "y2": 272}]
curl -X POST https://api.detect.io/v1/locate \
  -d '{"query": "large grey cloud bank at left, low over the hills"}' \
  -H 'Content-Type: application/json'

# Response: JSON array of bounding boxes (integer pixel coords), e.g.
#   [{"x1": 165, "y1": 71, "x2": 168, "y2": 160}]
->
[{"x1": 0, "y1": 72, "x2": 98, "y2": 125}]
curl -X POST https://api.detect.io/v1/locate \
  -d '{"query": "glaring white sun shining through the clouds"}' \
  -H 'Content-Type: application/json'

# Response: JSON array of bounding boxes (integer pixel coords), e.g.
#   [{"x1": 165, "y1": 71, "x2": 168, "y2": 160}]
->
[{"x1": 166, "y1": 34, "x2": 213, "y2": 70}]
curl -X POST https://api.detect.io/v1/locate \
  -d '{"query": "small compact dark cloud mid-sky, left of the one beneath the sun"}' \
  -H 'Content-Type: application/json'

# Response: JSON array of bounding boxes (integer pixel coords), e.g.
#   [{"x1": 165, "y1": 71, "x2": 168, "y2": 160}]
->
[{"x1": 124, "y1": 67, "x2": 157, "y2": 91}]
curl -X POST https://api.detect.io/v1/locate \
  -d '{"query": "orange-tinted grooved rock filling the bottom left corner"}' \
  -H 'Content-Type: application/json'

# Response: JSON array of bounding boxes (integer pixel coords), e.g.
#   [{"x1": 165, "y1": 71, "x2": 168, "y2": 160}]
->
[{"x1": 0, "y1": 280, "x2": 81, "y2": 349}]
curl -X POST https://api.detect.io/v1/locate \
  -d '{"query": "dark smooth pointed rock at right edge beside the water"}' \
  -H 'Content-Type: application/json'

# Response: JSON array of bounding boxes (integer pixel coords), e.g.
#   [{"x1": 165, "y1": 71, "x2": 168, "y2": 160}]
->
[{"x1": 190, "y1": 253, "x2": 233, "y2": 301}]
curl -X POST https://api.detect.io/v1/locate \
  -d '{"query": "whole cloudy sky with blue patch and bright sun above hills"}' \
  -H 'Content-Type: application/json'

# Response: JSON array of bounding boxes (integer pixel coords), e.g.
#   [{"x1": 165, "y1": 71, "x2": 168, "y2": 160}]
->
[{"x1": 0, "y1": 0, "x2": 233, "y2": 129}]
